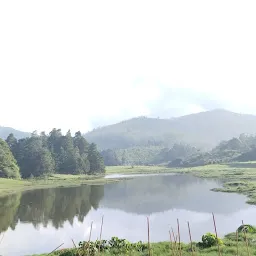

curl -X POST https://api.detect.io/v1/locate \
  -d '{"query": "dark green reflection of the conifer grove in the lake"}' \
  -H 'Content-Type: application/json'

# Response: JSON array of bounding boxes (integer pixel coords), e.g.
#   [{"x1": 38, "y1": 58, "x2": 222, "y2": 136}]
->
[{"x1": 0, "y1": 185, "x2": 104, "y2": 232}]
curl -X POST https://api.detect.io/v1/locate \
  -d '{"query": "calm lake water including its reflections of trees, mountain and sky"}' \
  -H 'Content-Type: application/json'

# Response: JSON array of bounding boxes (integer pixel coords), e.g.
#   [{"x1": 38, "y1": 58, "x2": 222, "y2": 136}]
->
[{"x1": 0, "y1": 174, "x2": 256, "y2": 256}]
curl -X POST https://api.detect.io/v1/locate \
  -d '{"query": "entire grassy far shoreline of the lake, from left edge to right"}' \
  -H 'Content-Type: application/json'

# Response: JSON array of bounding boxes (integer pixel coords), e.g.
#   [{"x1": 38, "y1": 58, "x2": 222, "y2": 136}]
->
[{"x1": 0, "y1": 162, "x2": 256, "y2": 205}]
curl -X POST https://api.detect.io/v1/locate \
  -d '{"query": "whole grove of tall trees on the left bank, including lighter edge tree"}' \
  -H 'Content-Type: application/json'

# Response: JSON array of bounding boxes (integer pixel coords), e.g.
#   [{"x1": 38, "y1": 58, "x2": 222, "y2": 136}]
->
[{"x1": 0, "y1": 129, "x2": 105, "y2": 178}]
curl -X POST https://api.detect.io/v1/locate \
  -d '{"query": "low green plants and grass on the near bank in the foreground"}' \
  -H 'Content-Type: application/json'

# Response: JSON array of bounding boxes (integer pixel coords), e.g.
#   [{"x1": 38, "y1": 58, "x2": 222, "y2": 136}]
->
[{"x1": 33, "y1": 226, "x2": 256, "y2": 256}]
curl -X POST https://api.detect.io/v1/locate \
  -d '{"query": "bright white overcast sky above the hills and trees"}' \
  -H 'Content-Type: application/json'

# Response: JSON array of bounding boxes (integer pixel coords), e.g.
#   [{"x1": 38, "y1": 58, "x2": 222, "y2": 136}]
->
[{"x1": 0, "y1": 0, "x2": 256, "y2": 132}]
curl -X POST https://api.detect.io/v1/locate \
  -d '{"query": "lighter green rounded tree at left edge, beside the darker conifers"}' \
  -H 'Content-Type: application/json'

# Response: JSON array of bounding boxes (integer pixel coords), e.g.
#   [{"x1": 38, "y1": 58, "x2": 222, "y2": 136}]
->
[{"x1": 0, "y1": 139, "x2": 20, "y2": 178}]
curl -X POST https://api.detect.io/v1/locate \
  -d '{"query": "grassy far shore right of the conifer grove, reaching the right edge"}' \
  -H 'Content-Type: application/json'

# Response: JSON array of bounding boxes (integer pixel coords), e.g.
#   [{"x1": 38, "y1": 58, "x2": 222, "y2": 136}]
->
[{"x1": 106, "y1": 164, "x2": 256, "y2": 205}]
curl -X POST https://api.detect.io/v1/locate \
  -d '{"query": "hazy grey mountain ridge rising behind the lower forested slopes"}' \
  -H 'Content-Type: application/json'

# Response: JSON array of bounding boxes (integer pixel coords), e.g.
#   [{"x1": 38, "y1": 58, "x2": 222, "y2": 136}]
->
[{"x1": 85, "y1": 109, "x2": 256, "y2": 149}]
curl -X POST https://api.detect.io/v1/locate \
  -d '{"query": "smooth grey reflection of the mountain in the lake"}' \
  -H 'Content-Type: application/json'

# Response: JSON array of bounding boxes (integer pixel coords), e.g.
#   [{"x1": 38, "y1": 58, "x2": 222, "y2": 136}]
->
[{"x1": 101, "y1": 175, "x2": 247, "y2": 214}]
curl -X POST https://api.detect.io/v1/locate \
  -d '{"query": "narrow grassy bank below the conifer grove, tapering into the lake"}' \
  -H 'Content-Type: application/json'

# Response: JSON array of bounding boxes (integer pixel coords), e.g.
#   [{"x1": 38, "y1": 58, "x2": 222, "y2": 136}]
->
[{"x1": 0, "y1": 174, "x2": 117, "y2": 197}]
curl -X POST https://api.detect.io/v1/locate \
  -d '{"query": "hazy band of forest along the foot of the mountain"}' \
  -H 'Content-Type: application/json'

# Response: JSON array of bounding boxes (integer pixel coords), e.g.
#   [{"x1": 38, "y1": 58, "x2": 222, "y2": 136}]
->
[{"x1": 101, "y1": 134, "x2": 256, "y2": 167}]
